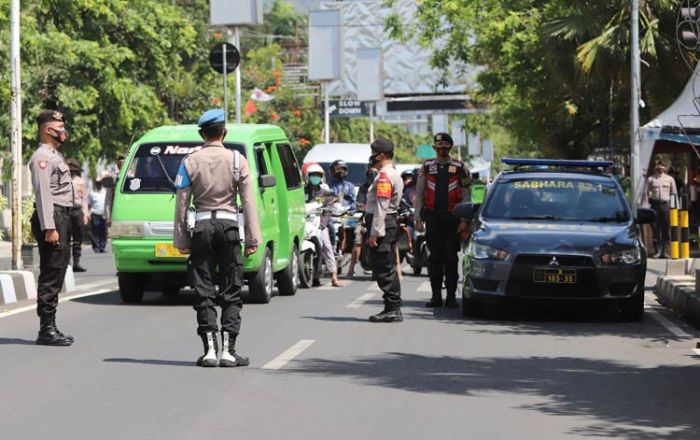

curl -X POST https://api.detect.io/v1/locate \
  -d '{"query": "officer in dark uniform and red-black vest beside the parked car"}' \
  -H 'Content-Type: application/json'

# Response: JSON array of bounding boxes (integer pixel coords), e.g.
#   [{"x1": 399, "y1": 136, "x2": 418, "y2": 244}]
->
[{"x1": 415, "y1": 133, "x2": 470, "y2": 308}]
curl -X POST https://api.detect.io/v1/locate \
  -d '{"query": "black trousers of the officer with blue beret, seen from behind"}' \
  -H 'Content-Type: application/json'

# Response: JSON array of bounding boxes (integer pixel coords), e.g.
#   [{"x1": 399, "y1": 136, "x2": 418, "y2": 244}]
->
[{"x1": 187, "y1": 219, "x2": 243, "y2": 335}]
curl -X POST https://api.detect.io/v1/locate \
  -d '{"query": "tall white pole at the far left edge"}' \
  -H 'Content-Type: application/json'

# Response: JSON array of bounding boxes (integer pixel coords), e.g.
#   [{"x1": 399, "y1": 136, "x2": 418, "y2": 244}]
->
[{"x1": 10, "y1": 0, "x2": 22, "y2": 270}]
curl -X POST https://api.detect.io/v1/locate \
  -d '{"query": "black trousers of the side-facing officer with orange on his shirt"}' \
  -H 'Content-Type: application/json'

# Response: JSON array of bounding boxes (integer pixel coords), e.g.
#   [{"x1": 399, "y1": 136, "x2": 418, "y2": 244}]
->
[{"x1": 365, "y1": 215, "x2": 401, "y2": 307}]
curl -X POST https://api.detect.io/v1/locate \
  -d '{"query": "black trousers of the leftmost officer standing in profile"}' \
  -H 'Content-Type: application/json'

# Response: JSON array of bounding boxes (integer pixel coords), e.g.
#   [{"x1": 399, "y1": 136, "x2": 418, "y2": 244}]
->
[{"x1": 31, "y1": 206, "x2": 70, "y2": 316}]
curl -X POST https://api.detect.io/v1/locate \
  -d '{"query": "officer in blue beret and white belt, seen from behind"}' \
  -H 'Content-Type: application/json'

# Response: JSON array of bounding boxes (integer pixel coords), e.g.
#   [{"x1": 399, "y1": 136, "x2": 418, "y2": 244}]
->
[{"x1": 174, "y1": 109, "x2": 262, "y2": 367}]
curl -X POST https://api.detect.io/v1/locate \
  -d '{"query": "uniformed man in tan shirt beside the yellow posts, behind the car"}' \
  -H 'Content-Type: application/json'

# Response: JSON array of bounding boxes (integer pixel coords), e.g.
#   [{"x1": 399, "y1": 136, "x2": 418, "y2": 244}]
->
[{"x1": 642, "y1": 160, "x2": 678, "y2": 258}]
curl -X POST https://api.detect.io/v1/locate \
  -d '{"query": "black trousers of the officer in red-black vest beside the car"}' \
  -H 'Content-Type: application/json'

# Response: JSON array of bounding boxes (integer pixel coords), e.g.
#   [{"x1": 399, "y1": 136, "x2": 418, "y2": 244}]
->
[{"x1": 424, "y1": 211, "x2": 460, "y2": 298}]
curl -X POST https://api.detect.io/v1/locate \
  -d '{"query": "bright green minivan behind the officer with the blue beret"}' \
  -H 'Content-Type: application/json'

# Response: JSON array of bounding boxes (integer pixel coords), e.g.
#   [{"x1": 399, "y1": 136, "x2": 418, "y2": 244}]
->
[{"x1": 111, "y1": 124, "x2": 306, "y2": 303}]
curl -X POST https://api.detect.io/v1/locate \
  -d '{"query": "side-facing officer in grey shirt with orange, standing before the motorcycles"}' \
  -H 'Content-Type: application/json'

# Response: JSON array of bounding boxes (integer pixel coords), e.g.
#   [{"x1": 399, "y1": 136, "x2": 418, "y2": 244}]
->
[{"x1": 365, "y1": 139, "x2": 403, "y2": 322}]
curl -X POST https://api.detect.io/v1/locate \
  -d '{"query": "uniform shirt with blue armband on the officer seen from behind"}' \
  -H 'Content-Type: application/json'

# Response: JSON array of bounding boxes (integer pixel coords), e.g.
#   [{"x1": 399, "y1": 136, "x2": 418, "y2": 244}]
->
[{"x1": 174, "y1": 142, "x2": 262, "y2": 249}]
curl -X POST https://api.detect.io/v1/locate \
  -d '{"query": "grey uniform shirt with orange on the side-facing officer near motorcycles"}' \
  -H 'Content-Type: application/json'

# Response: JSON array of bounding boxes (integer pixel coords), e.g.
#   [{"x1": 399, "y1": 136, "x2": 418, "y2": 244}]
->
[{"x1": 367, "y1": 165, "x2": 403, "y2": 237}]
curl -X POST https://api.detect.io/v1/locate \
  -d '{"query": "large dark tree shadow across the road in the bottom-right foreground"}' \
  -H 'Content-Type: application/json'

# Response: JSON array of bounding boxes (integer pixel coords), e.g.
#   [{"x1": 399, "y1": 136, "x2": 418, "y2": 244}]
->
[{"x1": 288, "y1": 353, "x2": 700, "y2": 440}]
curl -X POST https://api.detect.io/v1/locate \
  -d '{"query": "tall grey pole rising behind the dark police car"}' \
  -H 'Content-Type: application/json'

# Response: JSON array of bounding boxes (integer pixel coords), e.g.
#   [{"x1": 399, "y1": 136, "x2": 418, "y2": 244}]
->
[{"x1": 630, "y1": 0, "x2": 643, "y2": 212}]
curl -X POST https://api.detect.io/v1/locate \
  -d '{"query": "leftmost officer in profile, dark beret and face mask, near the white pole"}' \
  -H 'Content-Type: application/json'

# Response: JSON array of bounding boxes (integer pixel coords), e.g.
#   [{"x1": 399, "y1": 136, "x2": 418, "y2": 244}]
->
[{"x1": 29, "y1": 110, "x2": 73, "y2": 346}]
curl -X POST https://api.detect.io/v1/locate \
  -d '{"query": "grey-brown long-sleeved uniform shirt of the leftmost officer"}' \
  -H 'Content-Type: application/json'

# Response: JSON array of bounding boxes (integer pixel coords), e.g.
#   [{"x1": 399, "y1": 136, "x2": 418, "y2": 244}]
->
[{"x1": 29, "y1": 144, "x2": 73, "y2": 231}]
